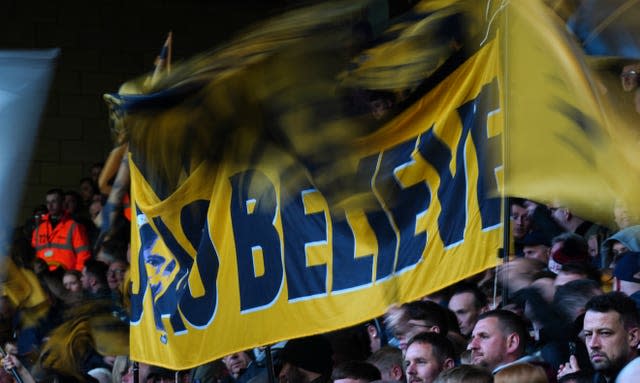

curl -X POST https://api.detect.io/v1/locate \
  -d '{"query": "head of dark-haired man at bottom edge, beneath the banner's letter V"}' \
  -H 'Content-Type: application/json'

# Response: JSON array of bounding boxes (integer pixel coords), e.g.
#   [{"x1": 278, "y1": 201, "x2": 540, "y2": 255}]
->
[{"x1": 404, "y1": 332, "x2": 456, "y2": 383}]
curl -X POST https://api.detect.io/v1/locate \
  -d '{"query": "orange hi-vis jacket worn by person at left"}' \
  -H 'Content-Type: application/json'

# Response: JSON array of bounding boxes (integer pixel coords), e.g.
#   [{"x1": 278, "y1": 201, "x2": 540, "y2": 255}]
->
[{"x1": 31, "y1": 214, "x2": 91, "y2": 271}]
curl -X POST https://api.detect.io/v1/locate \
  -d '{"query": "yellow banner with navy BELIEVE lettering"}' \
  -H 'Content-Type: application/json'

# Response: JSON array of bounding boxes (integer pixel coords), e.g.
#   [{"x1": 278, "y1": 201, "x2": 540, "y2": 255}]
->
[{"x1": 130, "y1": 38, "x2": 503, "y2": 369}]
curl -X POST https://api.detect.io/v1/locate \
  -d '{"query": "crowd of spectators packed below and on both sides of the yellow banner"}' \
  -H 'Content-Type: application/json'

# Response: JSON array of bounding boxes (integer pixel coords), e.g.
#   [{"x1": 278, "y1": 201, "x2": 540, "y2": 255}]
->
[{"x1": 0, "y1": 159, "x2": 640, "y2": 383}]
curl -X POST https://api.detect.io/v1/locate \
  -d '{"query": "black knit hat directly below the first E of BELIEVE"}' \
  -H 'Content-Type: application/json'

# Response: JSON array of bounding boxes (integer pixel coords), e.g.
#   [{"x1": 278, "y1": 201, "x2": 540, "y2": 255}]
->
[{"x1": 282, "y1": 335, "x2": 333, "y2": 375}]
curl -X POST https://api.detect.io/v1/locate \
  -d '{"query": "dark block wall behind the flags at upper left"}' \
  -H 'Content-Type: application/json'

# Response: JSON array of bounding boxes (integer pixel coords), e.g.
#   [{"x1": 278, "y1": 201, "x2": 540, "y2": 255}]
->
[{"x1": 0, "y1": 0, "x2": 304, "y2": 223}]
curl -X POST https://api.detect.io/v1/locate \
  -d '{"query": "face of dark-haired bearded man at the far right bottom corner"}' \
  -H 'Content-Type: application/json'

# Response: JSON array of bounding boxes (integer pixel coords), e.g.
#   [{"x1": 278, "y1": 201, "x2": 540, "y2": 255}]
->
[{"x1": 583, "y1": 310, "x2": 638, "y2": 373}]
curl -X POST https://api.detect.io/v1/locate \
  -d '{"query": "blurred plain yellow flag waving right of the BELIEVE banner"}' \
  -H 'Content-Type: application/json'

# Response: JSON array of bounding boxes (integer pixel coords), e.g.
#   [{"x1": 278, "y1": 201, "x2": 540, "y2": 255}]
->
[{"x1": 499, "y1": 1, "x2": 640, "y2": 224}]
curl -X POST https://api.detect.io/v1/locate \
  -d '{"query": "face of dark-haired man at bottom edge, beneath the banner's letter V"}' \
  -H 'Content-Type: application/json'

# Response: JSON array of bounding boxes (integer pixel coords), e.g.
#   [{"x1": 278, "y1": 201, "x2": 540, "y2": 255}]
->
[{"x1": 404, "y1": 342, "x2": 453, "y2": 383}]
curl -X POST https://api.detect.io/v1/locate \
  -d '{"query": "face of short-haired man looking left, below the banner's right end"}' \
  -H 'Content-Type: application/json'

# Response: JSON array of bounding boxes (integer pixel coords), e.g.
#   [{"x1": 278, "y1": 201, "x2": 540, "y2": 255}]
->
[{"x1": 467, "y1": 317, "x2": 507, "y2": 370}]
